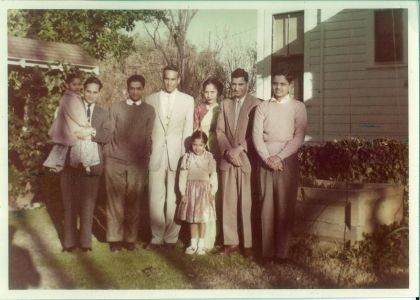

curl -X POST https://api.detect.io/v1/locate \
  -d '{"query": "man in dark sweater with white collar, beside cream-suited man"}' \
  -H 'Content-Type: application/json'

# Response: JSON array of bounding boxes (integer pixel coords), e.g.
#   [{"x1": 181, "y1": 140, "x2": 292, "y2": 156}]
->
[{"x1": 105, "y1": 75, "x2": 155, "y2": 252}]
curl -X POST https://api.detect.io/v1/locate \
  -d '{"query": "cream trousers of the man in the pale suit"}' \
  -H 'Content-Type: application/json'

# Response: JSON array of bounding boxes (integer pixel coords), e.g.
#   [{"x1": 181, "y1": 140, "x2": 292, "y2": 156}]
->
[{"x1": 149, "y1": 151, "x2": 181, "y2": 244}]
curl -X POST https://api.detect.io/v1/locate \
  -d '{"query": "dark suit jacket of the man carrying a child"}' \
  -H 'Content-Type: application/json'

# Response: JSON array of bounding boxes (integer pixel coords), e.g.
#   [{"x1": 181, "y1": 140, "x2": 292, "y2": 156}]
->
[{"x1": 87, "y1": 105, "x2": 112, "y2": 176}]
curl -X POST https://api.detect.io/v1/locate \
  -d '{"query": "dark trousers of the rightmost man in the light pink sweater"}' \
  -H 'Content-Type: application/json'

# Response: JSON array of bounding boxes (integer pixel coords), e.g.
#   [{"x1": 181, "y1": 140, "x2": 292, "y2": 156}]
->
[{"x1": 260, "y1": 154, "x2": 299, "y2": 258}]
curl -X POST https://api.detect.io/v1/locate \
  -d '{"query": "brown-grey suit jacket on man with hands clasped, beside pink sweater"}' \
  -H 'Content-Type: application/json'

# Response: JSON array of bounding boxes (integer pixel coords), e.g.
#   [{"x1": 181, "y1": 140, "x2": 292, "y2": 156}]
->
[{"x1": 216, "y1": 94, "x2": 260, "y2": 173}]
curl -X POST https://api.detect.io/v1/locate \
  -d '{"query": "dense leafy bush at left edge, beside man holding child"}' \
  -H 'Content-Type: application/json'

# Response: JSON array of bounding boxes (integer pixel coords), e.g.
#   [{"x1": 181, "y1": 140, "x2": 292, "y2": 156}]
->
[{"x1": 8, "y1": 66, "x2": 84, "y2": 201}]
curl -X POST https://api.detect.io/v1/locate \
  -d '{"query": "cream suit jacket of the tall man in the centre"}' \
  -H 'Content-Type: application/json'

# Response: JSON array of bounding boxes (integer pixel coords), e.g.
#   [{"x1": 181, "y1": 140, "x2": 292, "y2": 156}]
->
[{"x1": 146, "y1": 91, "x2": 194, "y2": 171}]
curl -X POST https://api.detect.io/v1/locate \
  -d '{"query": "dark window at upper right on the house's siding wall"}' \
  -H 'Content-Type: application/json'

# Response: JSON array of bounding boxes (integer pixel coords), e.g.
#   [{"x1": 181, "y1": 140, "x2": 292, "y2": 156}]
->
[{"x1": 375, "y1": 9, "x2": 404, "y2": 63}]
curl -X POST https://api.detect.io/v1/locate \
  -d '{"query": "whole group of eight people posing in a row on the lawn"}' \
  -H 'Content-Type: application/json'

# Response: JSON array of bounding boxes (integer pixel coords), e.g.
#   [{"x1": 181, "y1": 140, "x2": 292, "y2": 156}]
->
[{"x1": 44, "y1": 66, "x2": 307, "y2": 261}]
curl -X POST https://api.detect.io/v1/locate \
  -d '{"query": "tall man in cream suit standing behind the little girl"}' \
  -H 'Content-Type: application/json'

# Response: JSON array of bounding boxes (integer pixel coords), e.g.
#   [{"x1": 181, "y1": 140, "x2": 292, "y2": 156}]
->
[{"x1": 146, "y1": 66, "x2": 194, "y2": 249}]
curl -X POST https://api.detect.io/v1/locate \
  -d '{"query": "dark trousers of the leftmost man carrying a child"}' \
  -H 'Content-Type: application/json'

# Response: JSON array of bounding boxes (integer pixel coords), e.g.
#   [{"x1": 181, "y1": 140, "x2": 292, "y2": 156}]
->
[{"x1": 60, "y1": 167, "x2": 99, "y2": 248}]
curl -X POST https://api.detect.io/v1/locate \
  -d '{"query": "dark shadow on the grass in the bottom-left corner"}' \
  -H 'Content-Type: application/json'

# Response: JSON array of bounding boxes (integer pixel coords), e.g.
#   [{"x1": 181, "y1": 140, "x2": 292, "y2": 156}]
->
[{"x1": 9, "y1": 226, "x2": 41, "y2": 290}]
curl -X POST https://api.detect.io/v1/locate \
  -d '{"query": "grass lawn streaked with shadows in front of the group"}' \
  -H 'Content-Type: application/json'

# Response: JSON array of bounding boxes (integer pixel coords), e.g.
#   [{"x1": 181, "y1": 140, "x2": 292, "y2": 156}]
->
[{"x1": 9, "y1": 207, "x2": 408, "y2": 289}]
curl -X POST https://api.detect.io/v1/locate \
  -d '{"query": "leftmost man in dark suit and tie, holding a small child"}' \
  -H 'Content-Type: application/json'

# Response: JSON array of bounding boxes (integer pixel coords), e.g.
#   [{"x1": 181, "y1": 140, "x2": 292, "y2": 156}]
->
[{"x1": 61, "y1": 77, "x2": 112, "y2": 252}]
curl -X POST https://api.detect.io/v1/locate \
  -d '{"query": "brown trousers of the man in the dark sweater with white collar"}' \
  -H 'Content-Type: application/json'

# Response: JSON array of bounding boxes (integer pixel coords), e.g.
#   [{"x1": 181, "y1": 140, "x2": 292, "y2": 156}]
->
[{"x1": 105, "y1": 157, "x2": 147, "y2": 243}]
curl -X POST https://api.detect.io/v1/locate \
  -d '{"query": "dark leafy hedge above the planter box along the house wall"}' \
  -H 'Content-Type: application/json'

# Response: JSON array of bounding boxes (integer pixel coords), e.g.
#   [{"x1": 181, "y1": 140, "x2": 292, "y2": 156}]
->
[{"x1": 298, "y1": 138, "x2": 408, "y2": 192}]
